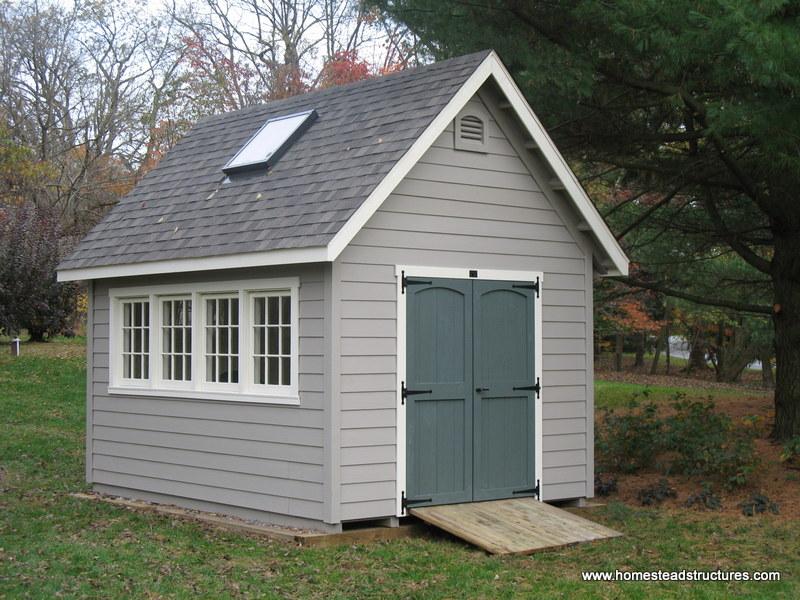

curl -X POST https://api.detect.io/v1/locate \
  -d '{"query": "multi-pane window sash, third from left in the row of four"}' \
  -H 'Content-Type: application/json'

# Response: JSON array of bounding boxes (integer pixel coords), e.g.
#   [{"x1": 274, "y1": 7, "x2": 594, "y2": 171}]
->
[{"x1": 205, "y1": 296, "x2": 239, "y2": 383}]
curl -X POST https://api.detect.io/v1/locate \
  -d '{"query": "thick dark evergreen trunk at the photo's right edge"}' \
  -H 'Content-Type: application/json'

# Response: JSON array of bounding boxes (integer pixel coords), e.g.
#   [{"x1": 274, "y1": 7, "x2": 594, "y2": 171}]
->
[{"x1": 772, "y1": 227, "x2": 800, "y2": 440}]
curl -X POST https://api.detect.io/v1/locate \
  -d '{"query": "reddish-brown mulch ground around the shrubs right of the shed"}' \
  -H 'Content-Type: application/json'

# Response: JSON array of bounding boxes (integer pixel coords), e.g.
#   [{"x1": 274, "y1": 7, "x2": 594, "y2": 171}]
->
[{"x1": 598, "y1": 394, "x2": 800, "y2": 520}]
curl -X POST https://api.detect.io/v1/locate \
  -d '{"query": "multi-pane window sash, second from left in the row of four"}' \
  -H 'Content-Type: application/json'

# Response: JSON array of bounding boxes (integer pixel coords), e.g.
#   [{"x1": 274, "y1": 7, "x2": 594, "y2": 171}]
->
[{"x1": 161, "y1": 298, "x2": 192, "y2": 381}]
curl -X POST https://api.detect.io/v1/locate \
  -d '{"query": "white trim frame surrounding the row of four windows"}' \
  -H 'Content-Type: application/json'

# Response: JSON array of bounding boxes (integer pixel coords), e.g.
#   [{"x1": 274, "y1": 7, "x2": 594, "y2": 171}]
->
[{"x1": 108, "y1": 277, "x2": 300, "y2": 405}]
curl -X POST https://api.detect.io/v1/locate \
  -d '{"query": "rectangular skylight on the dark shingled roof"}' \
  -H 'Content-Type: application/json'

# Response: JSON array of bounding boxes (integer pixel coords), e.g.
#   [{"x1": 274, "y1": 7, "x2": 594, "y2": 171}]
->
[{"x1": 222, "y1": 110, "x2": 317, "y2": 175}]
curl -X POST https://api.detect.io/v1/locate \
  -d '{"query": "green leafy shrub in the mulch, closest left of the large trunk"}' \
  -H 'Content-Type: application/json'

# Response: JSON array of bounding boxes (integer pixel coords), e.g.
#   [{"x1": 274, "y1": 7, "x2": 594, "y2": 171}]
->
[{"x1": 664, "y1": 398, "x2": 756, "y2": 487}]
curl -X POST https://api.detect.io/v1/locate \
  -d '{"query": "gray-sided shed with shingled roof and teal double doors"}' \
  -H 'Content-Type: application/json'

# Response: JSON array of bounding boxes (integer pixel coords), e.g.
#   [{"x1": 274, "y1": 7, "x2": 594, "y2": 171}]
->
[{"x1": 59, "y1": 52, "x2": 628, "y2": 531}]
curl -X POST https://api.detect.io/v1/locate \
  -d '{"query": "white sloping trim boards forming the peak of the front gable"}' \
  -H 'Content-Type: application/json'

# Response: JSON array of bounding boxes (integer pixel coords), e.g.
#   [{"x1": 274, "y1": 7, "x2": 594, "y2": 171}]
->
[{"x1": 328, "y1": 52, "x2": 628, "y2": 275}]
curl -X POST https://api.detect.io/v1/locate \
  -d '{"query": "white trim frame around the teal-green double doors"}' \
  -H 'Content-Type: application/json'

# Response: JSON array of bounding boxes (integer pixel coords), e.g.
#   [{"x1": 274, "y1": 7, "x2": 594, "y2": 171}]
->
[{"x1": 395, "y1": 265, "x2": 545, "y2": 517}]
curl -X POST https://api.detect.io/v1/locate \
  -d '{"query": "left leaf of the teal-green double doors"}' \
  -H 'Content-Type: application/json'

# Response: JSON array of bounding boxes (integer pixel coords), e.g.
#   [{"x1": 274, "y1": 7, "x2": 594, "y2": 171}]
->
[{"x1": 406, "y1": 279, "x2": 473, "y2": 505}]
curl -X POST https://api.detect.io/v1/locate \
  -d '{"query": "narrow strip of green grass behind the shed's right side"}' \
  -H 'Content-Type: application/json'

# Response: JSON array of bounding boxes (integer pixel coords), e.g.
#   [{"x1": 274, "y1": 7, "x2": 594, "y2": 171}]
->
[{"x1": 594, "y1": 379, "x2": 767, "y2": 408}]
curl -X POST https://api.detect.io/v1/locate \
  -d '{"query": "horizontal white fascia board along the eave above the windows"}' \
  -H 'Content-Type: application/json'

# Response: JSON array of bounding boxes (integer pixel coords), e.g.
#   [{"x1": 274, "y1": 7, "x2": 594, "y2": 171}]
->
[{"x1": 58, "y1": 246, "x2": 331, "y2": 281}]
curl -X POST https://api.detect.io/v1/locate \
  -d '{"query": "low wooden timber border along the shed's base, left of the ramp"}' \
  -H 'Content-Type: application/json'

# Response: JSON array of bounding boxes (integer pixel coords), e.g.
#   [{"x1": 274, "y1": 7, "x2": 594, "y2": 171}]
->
[{"x1": 70, "y1": 493, "x2": 424, "y2": 548}]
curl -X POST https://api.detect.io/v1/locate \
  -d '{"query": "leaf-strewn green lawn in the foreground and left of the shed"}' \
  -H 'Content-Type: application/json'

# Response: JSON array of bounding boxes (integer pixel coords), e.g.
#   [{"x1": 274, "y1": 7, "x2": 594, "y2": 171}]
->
[{"x1": 0, "y1": 349, "x2": 800, "y2": 599}]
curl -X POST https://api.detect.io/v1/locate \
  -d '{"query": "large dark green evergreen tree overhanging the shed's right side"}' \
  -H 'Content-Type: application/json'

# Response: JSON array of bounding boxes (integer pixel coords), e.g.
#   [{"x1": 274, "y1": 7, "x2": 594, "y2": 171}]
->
[{"x1": 381, "y1": 0, "x2": 800, "y2": 439}]
